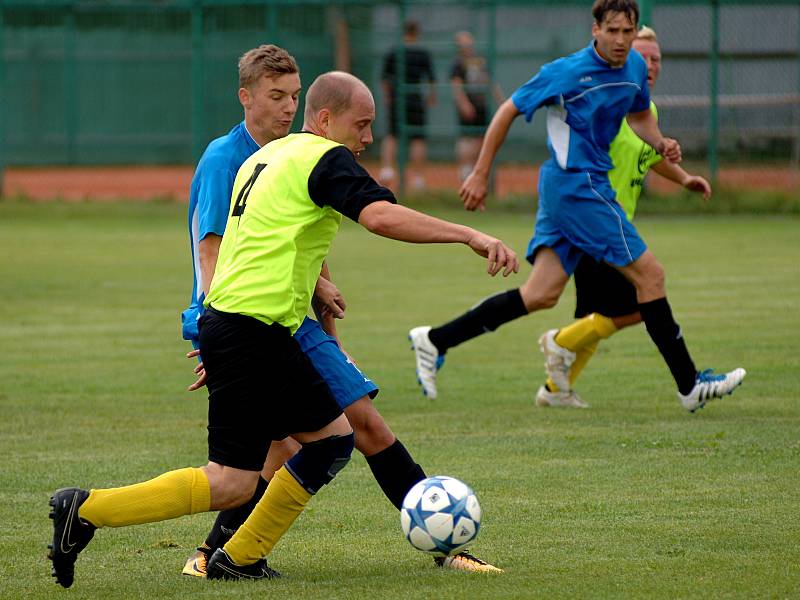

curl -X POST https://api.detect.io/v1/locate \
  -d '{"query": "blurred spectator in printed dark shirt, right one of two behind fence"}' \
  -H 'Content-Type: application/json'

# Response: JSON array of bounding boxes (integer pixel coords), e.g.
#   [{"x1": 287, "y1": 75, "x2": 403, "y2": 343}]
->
[{"x1": 450, "y1": 31, "x2": 503, "y2": 182}]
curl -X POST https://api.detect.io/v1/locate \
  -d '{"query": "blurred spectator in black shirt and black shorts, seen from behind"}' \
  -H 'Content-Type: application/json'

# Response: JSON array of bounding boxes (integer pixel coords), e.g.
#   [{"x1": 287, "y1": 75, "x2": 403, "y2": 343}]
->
[{"x1": 378, "y1": 21, "x2": 436, "y2": 190}]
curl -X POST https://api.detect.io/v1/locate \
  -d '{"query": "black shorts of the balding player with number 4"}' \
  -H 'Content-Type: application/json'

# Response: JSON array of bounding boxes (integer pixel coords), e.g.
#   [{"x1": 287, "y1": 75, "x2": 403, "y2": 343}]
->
[{"x1": 200, "y1": 309, "x2": 342, "y2": 471}]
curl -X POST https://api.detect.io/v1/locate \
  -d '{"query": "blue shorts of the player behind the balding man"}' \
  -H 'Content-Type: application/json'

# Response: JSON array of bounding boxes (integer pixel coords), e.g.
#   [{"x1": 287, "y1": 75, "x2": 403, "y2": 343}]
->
[{"x1": 294, "y1": 318, "x2": 378, "y2": 410}]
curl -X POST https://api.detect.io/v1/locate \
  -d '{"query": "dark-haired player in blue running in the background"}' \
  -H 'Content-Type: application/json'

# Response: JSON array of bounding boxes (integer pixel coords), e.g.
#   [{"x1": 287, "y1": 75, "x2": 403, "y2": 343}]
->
[{"x1": 409, "y1": 0, "x2": 745, "y2": 411}]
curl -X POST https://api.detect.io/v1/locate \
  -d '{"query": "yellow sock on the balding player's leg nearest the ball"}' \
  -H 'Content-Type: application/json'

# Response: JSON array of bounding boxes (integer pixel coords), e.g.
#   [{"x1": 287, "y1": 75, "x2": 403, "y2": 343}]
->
[{"x1": 224, "y1": 467, "x2": 311, "y2": 565}]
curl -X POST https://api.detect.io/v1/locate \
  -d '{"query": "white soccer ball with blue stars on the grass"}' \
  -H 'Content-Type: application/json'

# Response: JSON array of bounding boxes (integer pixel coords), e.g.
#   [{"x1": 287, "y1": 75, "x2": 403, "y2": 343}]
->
[{"x1": 400, "y1": 475, "x2": 481, "y2": 555}]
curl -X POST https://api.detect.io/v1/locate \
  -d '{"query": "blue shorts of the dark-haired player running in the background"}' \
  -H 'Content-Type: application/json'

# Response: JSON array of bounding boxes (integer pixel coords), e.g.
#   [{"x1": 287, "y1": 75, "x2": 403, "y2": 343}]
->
[{"x1": 526, "y1": 161, "x2": 647, "y2": 275}]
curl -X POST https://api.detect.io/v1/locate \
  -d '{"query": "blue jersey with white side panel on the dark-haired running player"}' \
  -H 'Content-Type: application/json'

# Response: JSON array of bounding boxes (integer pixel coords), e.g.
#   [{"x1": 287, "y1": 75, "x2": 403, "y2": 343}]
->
[{"x1": 511, "y1": 41, "x2": 650, "y2": 173}]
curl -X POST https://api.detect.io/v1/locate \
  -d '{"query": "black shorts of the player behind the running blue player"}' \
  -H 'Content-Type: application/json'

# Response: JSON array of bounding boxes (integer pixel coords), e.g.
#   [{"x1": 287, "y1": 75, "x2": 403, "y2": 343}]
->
[{"x1": 574, "y1": 255, "x2": 639, "y2": 319}]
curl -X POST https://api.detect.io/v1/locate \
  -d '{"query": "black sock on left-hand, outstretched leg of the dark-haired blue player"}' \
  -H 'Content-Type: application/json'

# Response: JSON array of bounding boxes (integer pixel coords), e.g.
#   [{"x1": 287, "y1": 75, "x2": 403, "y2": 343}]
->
[{"x1": 428, "y1": 288, "x2": 528, "y2": 354}]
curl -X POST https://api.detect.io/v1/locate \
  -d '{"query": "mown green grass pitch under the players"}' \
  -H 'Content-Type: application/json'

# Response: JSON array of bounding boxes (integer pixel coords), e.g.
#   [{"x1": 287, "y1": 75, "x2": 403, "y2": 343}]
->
[{"x1": 0, "y1": 203, "x2": 800, "y2": 599}]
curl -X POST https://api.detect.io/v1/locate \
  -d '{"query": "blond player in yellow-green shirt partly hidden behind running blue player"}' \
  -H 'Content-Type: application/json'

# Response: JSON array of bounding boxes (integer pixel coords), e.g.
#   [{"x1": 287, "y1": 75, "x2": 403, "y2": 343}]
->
[{"x1": 536, "y1": 27, "x2": 711, "y2": 408}]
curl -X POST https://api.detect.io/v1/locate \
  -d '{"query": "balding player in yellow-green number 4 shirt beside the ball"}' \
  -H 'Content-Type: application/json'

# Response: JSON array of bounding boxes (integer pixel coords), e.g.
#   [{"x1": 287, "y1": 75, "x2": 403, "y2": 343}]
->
[{"x1": 49, "y1": 72, "x2": 519, "y2": 587}]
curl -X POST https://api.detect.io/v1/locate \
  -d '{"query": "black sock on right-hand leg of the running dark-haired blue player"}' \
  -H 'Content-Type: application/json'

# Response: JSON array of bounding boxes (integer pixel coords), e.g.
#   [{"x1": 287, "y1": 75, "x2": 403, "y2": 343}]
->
[{"x1": 639, "y1": 298, "x2": 697, "y2": 395}]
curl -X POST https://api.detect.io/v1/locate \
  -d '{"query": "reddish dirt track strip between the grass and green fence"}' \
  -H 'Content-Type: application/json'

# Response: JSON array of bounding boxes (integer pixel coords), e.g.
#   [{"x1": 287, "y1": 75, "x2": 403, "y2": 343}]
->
[{"x1": 2, "y1": 163, "x2": 800, "y2": 202}]
